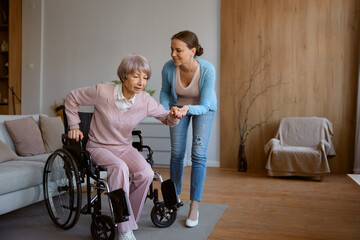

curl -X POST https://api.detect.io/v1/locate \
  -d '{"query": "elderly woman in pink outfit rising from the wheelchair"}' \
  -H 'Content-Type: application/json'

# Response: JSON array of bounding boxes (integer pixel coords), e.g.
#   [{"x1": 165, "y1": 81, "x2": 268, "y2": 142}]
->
[{"x1": 65, "y1": 55, "x2": 179, "y2": 239}]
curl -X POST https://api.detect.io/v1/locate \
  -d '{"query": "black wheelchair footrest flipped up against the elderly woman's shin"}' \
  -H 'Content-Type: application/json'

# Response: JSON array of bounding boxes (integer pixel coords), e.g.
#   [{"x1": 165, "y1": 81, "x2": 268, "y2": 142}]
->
[{"x1": 107, "y1": 188, "x2": 130, "y2": 223}]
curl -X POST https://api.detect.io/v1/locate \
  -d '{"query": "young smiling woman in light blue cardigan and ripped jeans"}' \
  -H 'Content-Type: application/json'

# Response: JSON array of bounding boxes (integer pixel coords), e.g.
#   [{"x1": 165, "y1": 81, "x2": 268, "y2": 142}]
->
[{"x1": 160, "y1": 31, "x2": 217, "y2": 227}]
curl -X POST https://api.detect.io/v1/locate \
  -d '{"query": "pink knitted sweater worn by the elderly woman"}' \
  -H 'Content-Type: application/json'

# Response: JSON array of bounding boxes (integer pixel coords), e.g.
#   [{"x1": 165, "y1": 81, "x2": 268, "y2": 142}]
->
[{"x1": 65, "y1": 84, "x2": 179, "y2": 149}]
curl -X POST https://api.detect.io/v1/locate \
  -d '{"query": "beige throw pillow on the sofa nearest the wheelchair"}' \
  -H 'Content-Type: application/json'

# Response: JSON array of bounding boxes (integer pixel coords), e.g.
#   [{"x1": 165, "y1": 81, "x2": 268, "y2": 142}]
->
[{"x1": 39, "y1": 115, "x2": 64, "y2": 153}]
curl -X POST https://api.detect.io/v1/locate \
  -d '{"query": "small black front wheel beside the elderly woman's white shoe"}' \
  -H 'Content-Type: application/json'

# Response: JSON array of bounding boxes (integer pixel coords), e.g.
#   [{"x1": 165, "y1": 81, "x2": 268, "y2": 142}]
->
[{"x1": 91, "y1": 215, "x2": 115, "y2": 240}]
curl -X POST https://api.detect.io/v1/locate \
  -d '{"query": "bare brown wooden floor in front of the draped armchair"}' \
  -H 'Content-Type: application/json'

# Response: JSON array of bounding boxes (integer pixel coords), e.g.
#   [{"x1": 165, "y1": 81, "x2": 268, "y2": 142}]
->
[{"x1": 155, "y1": 167, "x2": 360, "y2": 240}]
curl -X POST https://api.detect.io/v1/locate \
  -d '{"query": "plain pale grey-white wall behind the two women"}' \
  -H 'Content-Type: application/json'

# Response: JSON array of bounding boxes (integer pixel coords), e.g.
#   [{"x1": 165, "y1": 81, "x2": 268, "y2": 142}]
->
[{"x1": 22, "y1": 0, "x2": 220, "y2": 166}]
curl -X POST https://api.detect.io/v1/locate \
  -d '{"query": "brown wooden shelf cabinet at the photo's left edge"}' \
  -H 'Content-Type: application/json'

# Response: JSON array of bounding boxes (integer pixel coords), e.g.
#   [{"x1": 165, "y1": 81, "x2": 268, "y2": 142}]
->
[{"x1": 0, "y1": 0, "x2": 22, "y2": 114}]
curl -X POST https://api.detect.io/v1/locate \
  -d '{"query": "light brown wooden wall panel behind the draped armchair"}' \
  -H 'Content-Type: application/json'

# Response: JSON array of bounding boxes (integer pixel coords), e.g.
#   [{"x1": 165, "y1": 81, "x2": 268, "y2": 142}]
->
[{"x1": 220, "y1": 0, "x2": 360, "y2": 173}]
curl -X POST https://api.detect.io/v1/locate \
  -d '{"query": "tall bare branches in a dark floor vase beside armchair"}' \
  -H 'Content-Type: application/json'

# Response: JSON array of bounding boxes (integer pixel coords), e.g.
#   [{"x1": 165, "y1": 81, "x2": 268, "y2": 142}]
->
[{"x1": 231, "y1": 48, "x2": 285, "y2": 172}]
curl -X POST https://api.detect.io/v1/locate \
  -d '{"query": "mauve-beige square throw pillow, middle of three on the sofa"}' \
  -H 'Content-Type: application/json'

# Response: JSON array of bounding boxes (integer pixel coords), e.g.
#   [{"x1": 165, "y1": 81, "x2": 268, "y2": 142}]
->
[{"x1": 4, "y1": 117, "x2": 45, "y2": 156}]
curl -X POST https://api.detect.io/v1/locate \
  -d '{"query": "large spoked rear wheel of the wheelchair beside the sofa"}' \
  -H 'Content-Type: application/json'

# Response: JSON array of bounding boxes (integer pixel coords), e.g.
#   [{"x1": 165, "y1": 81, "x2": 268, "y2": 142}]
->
[{"x1": 43, "y1": 149, "x2": 81, "y2": 229}]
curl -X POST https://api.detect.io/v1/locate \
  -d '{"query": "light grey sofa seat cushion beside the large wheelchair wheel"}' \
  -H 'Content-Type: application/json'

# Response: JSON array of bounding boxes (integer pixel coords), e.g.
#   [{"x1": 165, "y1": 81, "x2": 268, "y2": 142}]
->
[{"x1": 0, "y1": 160, "x2": 45, "y2": 194}]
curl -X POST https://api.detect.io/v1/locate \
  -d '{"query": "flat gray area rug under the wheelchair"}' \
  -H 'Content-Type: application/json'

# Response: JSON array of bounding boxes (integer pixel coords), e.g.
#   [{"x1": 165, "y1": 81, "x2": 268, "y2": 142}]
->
[{"x1": 0, "y1": 200, "x2": 227, "y2": 240}]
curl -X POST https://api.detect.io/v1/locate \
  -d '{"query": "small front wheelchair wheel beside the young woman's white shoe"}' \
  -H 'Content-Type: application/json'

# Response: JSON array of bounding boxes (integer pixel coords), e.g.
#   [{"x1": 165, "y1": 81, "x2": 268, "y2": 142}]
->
[{"x1": 151, "y1": 201, "x2": 177, "y2": 228}]
